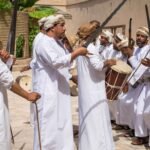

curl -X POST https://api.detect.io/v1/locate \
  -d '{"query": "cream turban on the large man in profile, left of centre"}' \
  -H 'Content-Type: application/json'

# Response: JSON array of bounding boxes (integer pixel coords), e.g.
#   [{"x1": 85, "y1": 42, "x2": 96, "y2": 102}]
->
[{"x1": 44, "y1": 15, "x2": 65, "y2": 30}]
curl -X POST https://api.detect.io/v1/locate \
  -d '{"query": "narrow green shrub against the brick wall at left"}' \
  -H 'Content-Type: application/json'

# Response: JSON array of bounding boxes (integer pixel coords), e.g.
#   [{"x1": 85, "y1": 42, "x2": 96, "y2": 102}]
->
[{"x1": 16, "y1": 34, "x2": 25, "y2": 58}]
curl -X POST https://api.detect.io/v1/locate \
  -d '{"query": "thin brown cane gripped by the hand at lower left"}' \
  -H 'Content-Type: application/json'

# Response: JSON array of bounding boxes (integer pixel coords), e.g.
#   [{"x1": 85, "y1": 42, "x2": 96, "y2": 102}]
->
[{"x1": 34, "y1": 102, "x2": 42, "y2": 150}]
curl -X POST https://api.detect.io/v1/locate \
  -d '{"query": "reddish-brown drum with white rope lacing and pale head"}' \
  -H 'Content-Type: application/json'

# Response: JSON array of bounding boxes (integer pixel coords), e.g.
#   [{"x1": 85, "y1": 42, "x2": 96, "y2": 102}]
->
[{"x1": 105, "y1": 60, "x2": 132, "y2": 100}]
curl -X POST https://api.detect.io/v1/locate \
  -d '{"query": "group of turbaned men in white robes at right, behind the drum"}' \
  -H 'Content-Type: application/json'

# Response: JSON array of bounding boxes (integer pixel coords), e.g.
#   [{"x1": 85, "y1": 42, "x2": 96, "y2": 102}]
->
[{"x1": 97, "y1": 27, "x2": 150, "y2": 145}]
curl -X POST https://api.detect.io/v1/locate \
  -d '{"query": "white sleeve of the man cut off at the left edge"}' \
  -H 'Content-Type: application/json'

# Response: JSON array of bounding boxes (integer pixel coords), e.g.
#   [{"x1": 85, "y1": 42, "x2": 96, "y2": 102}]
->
[{"x1": 0, "y1": 60, "x2": 13, "y2": 89}]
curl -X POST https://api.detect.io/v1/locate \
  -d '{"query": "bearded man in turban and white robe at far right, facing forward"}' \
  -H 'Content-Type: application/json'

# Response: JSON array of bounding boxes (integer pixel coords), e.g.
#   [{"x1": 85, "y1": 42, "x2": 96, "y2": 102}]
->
[{"x1": 120, "y1": 27, "x2": 150, "y2": 145}]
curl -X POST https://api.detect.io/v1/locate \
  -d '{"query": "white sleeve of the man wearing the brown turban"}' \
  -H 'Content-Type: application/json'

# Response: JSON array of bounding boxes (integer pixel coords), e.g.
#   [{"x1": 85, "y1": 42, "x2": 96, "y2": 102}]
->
[{"x1": 87, "y1": 43, "x2": 104, "y2": 71}]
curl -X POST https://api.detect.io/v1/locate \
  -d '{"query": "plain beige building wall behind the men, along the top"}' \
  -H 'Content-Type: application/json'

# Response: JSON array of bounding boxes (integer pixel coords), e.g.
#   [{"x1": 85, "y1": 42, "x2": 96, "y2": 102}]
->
[{"x1": 37, "y1": 0, "x2": 150, "y2": 37}]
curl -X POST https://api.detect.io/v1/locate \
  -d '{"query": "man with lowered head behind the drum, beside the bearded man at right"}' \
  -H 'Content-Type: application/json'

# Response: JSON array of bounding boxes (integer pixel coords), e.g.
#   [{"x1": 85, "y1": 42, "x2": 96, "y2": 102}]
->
[{"x1": 116, "y1": 38, "x2": 135, "y2": 137}]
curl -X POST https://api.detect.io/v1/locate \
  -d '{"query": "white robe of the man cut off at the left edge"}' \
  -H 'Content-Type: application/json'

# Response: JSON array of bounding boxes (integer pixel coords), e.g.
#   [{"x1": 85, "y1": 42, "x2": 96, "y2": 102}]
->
[{"x1": 0, "y1": 60, "x2": 13, "y2": 150}]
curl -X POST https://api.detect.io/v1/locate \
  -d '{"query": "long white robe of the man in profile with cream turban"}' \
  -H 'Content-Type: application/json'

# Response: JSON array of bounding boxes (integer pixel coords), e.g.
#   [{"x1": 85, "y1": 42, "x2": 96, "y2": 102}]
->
[{"x1": 33, "y1": 35, "x2": 74, "y2": 150}]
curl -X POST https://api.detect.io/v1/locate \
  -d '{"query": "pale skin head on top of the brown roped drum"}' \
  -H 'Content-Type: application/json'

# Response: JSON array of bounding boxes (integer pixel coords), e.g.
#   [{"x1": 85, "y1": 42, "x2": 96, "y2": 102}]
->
[{"x1": 111, "y1": 60, "x2": 132, "y2": 74}]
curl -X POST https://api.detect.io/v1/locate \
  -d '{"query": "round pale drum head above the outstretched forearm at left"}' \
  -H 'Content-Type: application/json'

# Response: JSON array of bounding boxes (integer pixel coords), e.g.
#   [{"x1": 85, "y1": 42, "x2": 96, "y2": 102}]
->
[{"x1": 16, "y1": 75, "x2": 32, "y2": 92}]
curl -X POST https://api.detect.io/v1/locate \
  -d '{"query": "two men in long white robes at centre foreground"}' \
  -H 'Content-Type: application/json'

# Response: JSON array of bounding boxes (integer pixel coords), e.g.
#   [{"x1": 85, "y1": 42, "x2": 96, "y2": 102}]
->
[{"x1": 26, "y1": 15, "x2": 115, "y2": 150}]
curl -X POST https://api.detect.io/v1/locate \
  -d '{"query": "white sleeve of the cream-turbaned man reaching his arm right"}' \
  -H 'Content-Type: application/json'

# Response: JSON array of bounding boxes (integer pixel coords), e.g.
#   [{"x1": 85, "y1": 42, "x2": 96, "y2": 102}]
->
[{"x1": 37, "y1": 40, "x2": 71, "y2": 69}]
